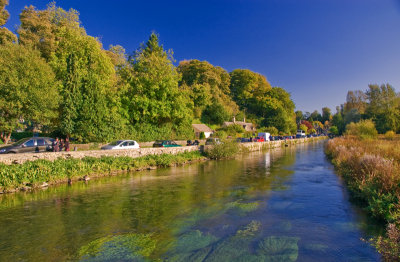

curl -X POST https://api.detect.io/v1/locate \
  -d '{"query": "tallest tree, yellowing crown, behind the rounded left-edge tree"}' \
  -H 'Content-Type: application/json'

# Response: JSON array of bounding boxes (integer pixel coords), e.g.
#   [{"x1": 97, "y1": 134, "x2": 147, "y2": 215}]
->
[{"x1": 18, "y1": 4, "x2": 124, "y2": 141}]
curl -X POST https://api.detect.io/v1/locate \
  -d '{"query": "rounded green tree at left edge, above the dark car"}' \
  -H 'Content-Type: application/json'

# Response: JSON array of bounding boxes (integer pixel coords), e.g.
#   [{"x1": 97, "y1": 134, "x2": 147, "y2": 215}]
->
[{"x1": 0, "y1": 44, "x2": 59, "y2": 143}]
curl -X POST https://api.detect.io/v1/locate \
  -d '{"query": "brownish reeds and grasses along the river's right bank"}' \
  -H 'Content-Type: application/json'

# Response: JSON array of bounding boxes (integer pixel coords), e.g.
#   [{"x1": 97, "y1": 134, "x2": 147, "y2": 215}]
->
[{"x1": 326, "y1": 137, "x2": 400, "y2": 261}]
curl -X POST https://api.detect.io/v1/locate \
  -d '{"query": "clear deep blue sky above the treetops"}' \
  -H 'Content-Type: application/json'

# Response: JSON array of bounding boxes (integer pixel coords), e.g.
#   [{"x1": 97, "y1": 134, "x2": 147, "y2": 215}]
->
[{"x1": 6, "y1": 0, "x2": 400, "y2": 112}]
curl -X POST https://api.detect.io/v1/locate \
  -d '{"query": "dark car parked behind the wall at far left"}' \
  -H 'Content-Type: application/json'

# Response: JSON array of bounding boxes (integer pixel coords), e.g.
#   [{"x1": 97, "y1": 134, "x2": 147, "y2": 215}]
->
[{"x1": 0, "y1": 137, "x2": 54, "y2": 154}]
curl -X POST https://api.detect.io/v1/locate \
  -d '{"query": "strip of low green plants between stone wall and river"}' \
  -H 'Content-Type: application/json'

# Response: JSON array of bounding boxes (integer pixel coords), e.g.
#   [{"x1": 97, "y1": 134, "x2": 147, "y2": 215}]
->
[{"x1": 0, "y1": 151, "x2": 205, "y2": 192}]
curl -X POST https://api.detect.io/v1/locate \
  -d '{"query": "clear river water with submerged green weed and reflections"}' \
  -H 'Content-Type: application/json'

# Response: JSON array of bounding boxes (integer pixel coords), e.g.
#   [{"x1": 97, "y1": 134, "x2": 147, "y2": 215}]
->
[{"x1": 0, "y1": 142, "x2": 380, "y2": 261}]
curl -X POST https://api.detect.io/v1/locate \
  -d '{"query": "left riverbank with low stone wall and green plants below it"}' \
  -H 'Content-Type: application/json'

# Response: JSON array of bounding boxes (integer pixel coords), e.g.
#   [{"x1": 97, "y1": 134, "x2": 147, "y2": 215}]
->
[{"x1": 0, "y1": 137, "x2": 324, "y2": 194}]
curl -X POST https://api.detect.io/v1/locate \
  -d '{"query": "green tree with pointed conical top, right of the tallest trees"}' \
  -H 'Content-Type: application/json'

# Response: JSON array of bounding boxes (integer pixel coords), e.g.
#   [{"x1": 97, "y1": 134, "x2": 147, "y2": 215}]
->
[{"x1": 123, "y1": 33, "x2": 193, "y2": 137}]
